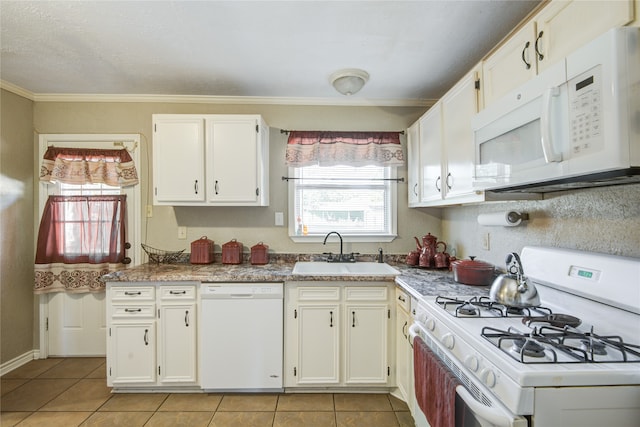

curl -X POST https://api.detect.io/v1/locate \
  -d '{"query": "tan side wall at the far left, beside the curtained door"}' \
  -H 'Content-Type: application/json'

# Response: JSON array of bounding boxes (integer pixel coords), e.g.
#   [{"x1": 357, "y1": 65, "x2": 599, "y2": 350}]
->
[{"x1": 0, "y1": 90, "x2": 35, "y2": 364}]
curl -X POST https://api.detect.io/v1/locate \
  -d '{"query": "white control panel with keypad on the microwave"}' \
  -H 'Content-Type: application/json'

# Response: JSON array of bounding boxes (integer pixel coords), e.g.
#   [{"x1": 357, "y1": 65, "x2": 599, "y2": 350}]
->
[{"x1": 568, "y1": 65, "x2": 604, "y2": 157}]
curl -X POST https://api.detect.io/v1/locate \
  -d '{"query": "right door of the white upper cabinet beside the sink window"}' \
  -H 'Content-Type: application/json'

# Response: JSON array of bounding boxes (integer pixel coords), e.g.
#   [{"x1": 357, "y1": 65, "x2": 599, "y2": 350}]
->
[{"x1": 207, "y1": 117, "x2": 262, "y2": 205}]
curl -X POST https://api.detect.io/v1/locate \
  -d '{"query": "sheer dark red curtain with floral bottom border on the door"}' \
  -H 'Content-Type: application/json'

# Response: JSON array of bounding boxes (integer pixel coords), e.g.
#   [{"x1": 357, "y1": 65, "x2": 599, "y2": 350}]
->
[{"x1": 35, "y1": 195, "x2": 126, "y2": 293}]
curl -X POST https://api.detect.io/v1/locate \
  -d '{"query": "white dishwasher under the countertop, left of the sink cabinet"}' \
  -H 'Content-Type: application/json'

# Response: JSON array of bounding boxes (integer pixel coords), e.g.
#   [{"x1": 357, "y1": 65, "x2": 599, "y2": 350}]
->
[{"x1": 199, "y1": 283, "x2": 283, "y2": 392}]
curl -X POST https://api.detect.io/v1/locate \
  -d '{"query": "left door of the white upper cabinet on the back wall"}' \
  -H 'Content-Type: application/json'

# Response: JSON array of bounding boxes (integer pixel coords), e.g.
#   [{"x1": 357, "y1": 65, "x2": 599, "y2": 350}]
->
[{"x1": 153, "y1": 115, "x2": 205, "y2": 205}]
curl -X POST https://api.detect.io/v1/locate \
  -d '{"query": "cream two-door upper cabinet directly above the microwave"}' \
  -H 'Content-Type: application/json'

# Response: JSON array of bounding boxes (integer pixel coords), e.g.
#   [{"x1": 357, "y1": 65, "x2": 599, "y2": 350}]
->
[{"x1": 482, "y1": 0, "x2": 633, "y2": 106}]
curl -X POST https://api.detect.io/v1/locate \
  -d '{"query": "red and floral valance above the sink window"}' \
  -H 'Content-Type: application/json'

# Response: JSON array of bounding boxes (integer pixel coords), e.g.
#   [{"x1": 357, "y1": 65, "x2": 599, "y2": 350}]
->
[{"x1": 285, "y1": 131, "x2": 404, "y2": 167}]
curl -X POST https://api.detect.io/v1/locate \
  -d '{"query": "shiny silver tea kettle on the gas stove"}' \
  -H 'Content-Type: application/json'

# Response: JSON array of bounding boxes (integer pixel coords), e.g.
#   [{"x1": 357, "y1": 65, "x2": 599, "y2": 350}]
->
[{"x1": 489, "y1": 252, "x2": 540, "y2": 307}]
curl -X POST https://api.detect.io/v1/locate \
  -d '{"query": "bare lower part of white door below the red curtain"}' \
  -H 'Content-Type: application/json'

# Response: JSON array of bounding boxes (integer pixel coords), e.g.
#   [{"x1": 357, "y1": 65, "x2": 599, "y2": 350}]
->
[{"x1": 49, "y1": 292, "x2": 107, "y2": 356}]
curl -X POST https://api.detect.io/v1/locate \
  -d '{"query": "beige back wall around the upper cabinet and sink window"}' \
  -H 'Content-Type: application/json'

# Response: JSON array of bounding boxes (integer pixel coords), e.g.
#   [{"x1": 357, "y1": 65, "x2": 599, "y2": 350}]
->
[{"x1": 34, "y1": 102, "x2": 440, "y2": 260}]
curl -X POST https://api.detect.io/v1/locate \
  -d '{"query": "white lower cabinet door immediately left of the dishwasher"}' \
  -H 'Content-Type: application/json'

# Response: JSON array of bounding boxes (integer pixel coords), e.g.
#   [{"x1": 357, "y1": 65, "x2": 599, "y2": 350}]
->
[{"x1": 158, "y1": 302, "x2": 197, "y2": 384}]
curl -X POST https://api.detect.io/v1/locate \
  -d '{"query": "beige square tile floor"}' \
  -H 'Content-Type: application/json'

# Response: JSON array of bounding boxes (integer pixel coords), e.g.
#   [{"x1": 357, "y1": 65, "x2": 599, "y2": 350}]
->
[{"x1": 0, "y1": 358, "x2": 414, "y2": 427}]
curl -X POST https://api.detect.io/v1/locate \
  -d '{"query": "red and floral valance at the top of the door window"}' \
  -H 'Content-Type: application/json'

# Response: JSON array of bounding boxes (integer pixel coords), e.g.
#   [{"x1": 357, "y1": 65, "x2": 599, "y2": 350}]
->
[{"x1": 40, "y1": 147, "x2": 138, "y2": 187}]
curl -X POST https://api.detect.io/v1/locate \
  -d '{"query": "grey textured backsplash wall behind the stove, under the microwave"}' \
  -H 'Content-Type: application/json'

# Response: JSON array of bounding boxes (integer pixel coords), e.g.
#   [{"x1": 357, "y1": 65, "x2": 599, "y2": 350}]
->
[{"x1": 442, "y1": 184, "x2": 640, "y2": 268}]
